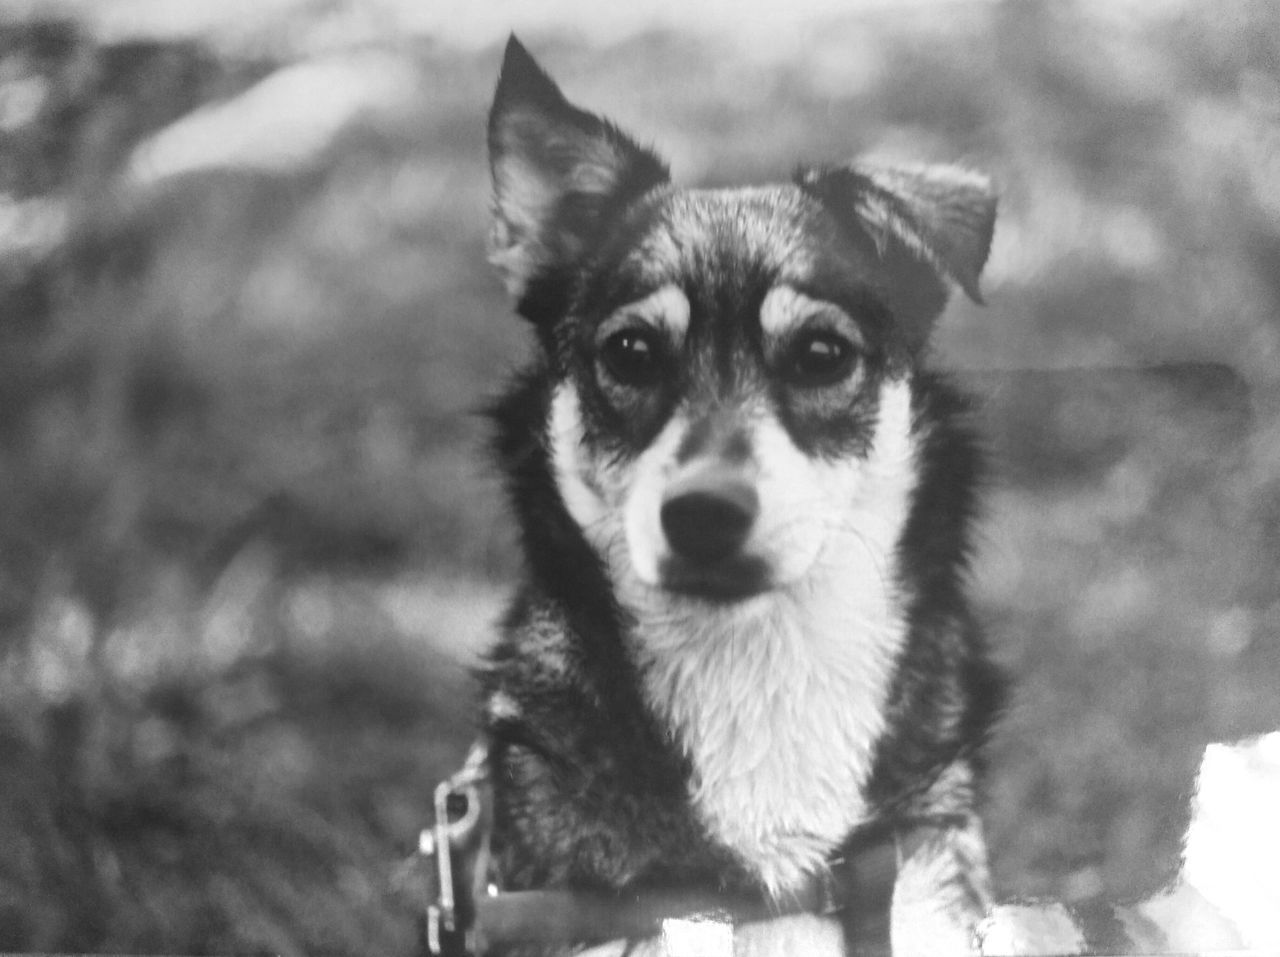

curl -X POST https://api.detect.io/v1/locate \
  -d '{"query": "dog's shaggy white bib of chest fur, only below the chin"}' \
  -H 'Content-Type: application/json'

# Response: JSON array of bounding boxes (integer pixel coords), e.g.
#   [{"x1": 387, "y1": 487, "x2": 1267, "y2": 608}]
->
[{"x1": 640, "y1": 581, "x2": 905, "y2": 890}]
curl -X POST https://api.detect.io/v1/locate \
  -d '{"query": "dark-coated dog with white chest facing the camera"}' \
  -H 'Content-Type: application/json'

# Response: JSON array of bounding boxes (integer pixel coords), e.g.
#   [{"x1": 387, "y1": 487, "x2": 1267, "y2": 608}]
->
[{"x1": 479, "y1": 37, "x2": 1002, "y2": 957}]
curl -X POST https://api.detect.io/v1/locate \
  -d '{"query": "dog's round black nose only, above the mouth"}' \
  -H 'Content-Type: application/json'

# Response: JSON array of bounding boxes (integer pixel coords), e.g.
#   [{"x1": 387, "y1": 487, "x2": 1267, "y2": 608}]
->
[{"x1": 662, "y1": 470, "x2": 760, "y2": 563}]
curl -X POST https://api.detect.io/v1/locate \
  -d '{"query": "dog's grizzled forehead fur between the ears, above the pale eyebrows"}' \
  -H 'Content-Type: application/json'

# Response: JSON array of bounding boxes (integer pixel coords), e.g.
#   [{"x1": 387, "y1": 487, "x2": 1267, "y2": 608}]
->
[{"x1": 623, "y1": 186, "x2": 831, "y2": 285}]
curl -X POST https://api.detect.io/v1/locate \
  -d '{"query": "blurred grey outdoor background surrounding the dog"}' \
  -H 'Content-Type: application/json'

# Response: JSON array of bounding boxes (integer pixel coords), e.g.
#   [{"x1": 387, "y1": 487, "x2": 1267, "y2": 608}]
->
[{"x1": 0, "y1": 0, "x2": 1280, "y2": 954}]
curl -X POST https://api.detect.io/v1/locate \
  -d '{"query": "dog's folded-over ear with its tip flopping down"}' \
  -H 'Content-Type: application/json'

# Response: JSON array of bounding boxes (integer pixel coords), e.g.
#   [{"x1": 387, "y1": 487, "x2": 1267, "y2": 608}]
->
[{"x1": 799, "y1": 162, "x2": 996, "y2": 303}]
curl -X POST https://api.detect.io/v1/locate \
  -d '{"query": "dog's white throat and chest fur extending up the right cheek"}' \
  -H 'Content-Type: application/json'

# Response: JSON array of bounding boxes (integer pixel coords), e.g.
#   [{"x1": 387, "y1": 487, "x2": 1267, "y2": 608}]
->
[{"x1": 620, "y1": 383, "x2": 918, "y2": 892}]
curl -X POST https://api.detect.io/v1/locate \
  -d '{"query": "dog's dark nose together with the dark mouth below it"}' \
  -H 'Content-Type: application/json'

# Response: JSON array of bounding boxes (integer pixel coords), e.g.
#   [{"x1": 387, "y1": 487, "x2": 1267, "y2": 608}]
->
[{"x1": 660, "y1": 464, "x2": 767, "y2": 600}]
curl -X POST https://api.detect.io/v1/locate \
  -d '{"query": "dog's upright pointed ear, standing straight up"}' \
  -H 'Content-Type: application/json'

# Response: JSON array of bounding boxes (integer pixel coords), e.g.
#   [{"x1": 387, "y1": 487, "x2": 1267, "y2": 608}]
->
[{"x1": 489, "y1": 36, "x2": 668, "y2": 303}]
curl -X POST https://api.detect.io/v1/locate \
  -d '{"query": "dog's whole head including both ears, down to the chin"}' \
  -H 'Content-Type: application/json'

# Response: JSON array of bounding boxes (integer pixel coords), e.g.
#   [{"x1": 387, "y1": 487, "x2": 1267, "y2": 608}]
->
[{"x1": 489, "y1": 38, "x2": 995, "y2": 614}]
